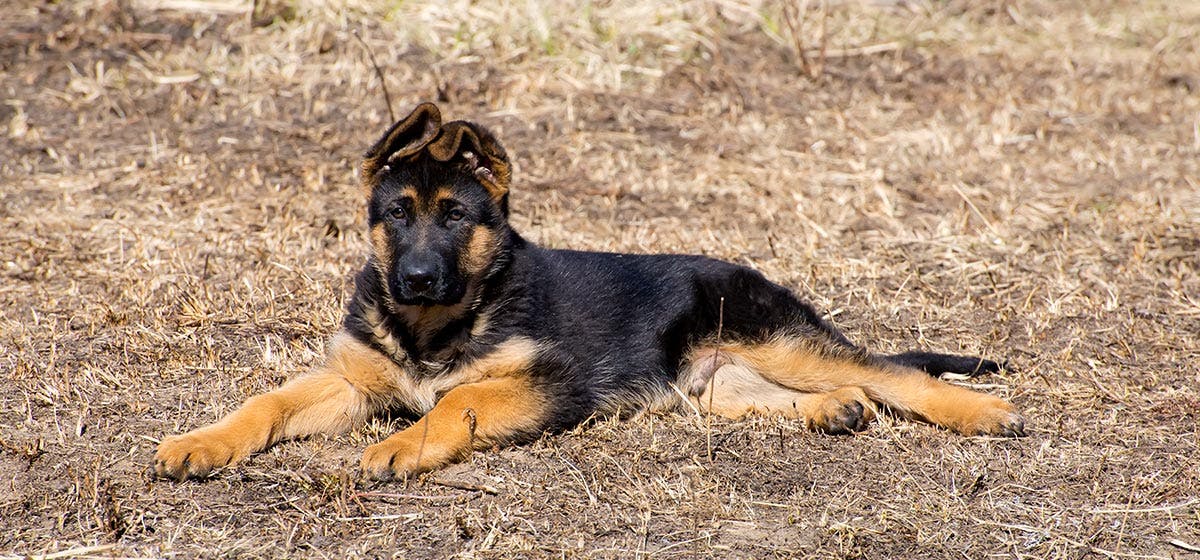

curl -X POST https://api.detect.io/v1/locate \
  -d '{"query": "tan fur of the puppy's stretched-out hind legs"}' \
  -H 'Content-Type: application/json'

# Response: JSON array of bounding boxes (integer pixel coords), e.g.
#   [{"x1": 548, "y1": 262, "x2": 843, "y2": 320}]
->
[{"x1": 679, "y1": 338, "x2": 1018, "y2": 435}]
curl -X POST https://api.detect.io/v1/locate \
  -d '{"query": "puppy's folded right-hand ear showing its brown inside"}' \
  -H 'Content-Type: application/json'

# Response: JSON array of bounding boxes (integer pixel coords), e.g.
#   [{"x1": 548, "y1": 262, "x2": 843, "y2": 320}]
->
[{"x1": 427, "y1": 121, "x2": 512, "y2": 205}]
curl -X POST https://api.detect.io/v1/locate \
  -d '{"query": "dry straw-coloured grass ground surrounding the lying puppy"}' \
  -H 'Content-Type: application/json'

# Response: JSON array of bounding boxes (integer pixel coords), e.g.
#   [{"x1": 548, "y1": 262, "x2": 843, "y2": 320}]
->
[{"x1": 0, "y1": 0, "x2": 1200, "y2": 558}]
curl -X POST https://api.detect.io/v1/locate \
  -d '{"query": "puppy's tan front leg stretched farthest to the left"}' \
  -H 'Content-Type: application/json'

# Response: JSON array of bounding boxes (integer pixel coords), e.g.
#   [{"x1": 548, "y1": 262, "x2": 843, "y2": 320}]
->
[{"x1": 155, "y1": 333, "x2": 401, "y2": 480}]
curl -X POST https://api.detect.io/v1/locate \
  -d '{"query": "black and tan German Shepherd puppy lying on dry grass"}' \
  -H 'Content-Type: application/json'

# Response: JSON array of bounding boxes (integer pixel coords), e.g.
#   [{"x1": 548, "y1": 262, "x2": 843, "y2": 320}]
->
[{"x1": 155, "y1": 103, "x2": 1025, "y2": 480}]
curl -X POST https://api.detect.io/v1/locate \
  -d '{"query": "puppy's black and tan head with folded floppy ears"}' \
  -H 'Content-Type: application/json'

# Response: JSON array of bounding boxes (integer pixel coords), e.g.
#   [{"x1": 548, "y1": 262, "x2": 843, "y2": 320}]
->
[{"x1": 361, "y1": 103, "x2": 510, "y2": 306}]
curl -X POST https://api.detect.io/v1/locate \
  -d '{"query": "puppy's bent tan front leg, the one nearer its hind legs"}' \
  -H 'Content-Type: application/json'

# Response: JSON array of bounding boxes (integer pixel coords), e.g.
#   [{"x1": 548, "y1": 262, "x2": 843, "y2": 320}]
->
[{"x1": 362, "y1": 374, "x2": 551, "y2": 480}]
